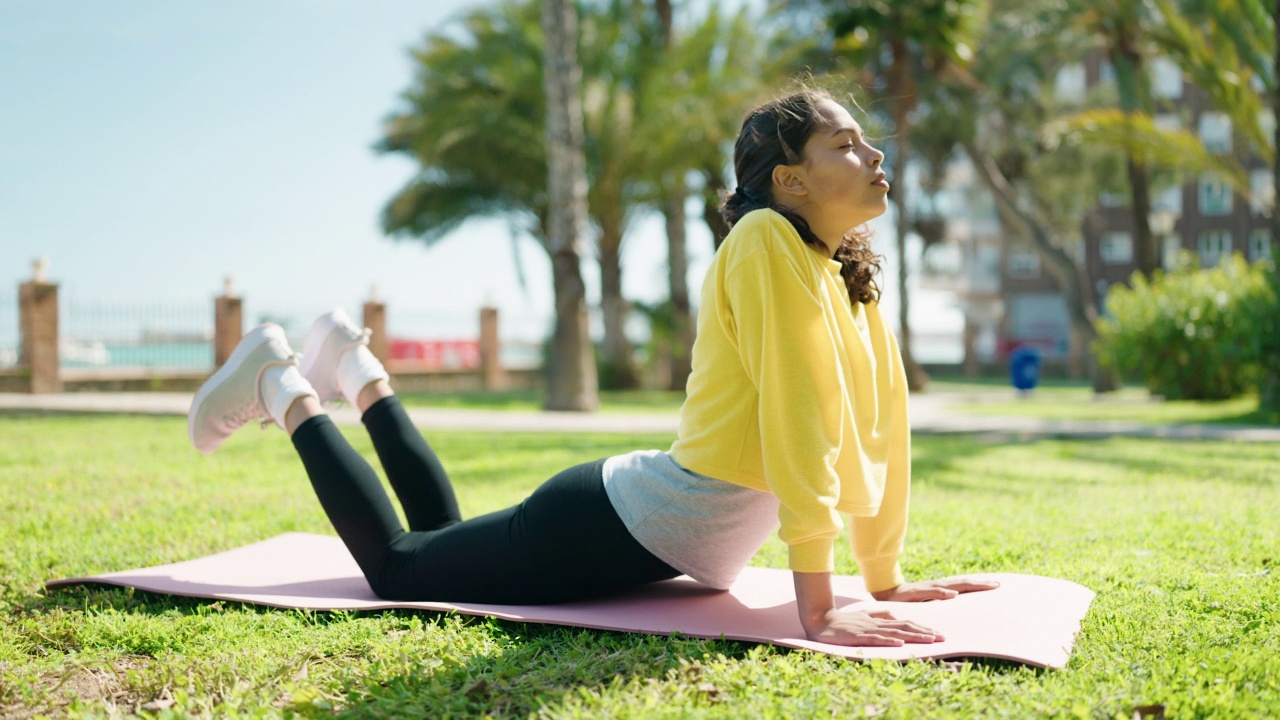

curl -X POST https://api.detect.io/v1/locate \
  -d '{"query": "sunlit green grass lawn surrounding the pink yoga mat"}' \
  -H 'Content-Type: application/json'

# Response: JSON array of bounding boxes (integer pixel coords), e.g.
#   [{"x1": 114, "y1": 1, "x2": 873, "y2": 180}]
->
[{"x1": 0, "y1": 416, "x2": 1280, "y2": 719}]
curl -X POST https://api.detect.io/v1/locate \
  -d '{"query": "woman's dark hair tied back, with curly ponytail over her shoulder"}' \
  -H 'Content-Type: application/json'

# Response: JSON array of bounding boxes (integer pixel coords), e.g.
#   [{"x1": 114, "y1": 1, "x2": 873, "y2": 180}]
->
[{"x1": 721, "y1": 90, "x2": 881, "y2": 302}]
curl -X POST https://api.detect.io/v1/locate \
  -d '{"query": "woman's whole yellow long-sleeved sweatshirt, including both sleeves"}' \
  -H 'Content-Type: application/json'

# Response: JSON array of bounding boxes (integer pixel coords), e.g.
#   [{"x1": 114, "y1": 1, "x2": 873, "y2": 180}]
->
[{"x1": 671, "y1": 210, "x2": 911, "y2": 591}]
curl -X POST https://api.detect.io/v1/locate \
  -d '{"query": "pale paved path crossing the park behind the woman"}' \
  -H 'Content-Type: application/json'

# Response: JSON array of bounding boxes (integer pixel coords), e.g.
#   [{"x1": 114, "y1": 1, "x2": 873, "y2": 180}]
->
[{"x1": 0, "y1": 392, "x2": 1280, "y2": 442}]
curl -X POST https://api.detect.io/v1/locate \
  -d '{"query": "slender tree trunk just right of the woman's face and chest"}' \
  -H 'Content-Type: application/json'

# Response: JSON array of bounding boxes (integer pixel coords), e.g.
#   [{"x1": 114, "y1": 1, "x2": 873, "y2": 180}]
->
[{"x1": 888, "y1": 41, "x2": 929, "y2": 392}]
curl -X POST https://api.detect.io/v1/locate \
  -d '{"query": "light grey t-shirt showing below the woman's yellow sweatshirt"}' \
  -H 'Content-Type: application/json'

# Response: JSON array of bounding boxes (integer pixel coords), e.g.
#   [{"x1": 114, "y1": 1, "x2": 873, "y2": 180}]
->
[{"x1": 604, "y1": 450, "x2": 778, "y2": 589}]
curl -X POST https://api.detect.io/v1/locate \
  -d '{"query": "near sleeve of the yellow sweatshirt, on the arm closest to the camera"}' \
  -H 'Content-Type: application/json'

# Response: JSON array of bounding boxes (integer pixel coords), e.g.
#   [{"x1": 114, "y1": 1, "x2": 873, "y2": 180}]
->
[{"x1": 724, "y1": 243, "x2": 842, "y2": 573}]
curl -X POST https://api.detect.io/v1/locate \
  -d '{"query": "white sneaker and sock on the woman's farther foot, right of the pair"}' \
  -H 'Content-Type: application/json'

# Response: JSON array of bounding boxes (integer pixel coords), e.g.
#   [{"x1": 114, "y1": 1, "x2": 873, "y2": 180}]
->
[{"x1": 298, "y1": 307, "x2": 390, "y2": 405}]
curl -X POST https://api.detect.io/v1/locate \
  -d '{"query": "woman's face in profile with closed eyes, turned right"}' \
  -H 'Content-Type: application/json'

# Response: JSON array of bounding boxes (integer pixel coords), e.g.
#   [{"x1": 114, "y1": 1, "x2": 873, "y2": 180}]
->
[{"x1": 795, "y1": 100, "x2": 888, "y2": 228}]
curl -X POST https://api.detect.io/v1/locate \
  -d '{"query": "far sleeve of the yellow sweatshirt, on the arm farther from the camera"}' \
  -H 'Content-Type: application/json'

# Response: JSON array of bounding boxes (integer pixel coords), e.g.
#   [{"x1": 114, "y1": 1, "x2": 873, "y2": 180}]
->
[{"x1": 850, "y1": 324, "x2": 911, "y2": 592}]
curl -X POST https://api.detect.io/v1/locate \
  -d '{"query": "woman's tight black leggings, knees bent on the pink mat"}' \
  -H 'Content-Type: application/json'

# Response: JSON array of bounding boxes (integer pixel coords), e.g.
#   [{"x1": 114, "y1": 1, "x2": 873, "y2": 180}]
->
[{"x1": 293, "y1": 397, "x2": 680, "y2": 605}]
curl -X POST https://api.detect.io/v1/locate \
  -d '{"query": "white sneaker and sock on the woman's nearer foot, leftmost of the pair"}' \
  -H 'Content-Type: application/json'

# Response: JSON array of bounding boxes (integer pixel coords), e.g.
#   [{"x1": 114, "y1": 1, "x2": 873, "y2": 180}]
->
[{"x1": 187, "y1": 324, "x2": 316, "y2": 455}]
